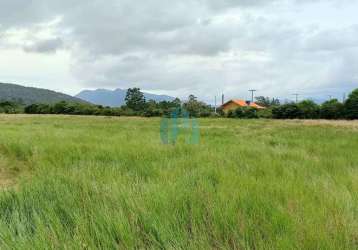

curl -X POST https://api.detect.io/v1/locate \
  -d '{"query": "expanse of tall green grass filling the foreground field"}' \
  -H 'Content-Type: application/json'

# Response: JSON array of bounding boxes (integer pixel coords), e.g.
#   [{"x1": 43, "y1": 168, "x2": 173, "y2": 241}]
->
[{"x1": 0, "y1": 116, "x2": 358, "y2": 249}]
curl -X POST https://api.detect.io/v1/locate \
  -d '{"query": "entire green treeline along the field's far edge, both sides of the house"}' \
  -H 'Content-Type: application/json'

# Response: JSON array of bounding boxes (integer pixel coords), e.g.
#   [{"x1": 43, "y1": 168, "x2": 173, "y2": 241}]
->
[{"x1": 0, "y1": 88, "x2": 358, "y2": 119}]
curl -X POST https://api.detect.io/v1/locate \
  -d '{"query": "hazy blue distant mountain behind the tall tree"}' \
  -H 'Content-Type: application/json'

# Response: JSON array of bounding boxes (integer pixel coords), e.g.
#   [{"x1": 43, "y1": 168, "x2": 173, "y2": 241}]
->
[{"x1": 76, "y1": 89, "x2": 175, "y2": 107}]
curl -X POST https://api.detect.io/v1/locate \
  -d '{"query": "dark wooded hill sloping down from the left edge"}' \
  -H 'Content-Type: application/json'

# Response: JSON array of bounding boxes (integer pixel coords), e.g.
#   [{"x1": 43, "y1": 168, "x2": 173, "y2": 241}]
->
[{"x1": 0, "y1": 83, "x2": 85, "y2": 105}]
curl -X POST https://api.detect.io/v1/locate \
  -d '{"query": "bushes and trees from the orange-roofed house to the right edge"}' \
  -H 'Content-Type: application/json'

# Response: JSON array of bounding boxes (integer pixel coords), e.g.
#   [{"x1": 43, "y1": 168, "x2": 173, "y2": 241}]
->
[{"x1": 226, "y1": 89, "x2": 358, "y2": 120}]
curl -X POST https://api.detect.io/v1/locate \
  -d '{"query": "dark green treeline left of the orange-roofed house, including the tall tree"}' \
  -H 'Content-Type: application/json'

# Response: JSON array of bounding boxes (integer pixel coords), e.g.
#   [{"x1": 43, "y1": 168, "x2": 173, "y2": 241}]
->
[{"x1": 0, "y1": 88, "x2": 214, "y2": 117}]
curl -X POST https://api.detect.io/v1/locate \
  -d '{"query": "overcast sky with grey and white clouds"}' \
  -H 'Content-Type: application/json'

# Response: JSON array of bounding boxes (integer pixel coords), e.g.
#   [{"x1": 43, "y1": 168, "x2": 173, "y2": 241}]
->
[{"x1": 0, "y1": 0, "x2": 358, "y2": 103}]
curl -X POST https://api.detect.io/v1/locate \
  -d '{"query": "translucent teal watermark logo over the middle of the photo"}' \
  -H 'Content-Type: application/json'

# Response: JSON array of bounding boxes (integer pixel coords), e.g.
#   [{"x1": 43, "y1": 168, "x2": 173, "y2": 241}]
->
[{"x1": 160, "y1": 109, "x2": 200, "y2": 145}]
